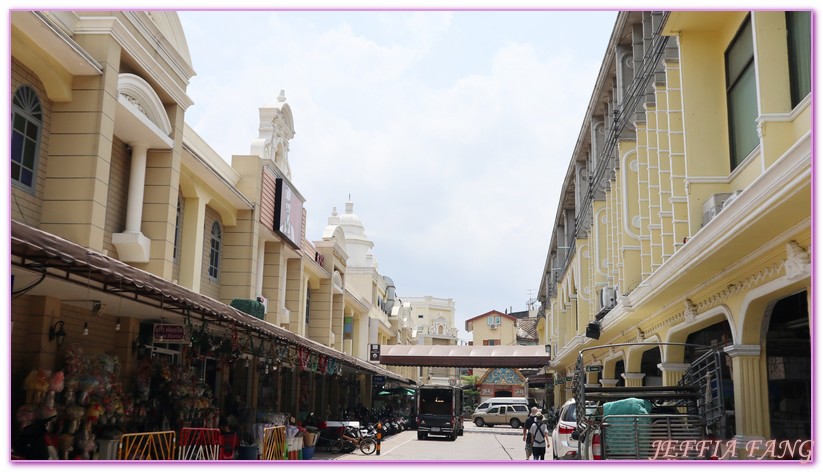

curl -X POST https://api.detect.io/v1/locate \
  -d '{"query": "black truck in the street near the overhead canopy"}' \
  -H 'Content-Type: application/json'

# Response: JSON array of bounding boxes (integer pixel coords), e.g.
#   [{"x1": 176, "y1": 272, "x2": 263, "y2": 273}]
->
[{"x1": 417, "y1": 385, "x2": 463, "y2": 441}]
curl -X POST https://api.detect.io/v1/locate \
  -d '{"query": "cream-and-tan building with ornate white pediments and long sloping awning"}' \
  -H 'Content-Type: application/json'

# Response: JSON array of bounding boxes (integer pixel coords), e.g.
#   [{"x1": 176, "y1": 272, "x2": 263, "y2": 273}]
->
[{"x1": 10, "y1": 11, "x2": 414, "y2": 454}]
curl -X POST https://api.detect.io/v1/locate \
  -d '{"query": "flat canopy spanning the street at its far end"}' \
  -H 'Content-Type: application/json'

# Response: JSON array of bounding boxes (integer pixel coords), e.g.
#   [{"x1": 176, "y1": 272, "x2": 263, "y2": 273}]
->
[{"x1": 380, "y1": 345, "x2": 550, "y2": 368}]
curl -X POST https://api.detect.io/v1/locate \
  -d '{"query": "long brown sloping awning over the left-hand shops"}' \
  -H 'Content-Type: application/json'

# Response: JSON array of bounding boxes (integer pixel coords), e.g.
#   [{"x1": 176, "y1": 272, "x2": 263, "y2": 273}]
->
[{"x1": 11, "y1": 221, "x2": 416, "y2": 385}]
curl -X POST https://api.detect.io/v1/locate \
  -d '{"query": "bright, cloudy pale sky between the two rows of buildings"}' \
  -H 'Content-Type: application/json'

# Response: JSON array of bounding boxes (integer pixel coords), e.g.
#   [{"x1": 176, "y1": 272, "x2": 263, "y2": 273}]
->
[{"x1": 180, "y1": 10, "x2": 617, "y2": 340}]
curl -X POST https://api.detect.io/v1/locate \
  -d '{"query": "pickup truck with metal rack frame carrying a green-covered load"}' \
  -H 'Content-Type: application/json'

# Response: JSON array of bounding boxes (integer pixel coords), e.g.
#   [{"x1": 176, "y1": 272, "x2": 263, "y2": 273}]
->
[{"x1": 572, "y1": 343, "x2": 725, "y2": 460}]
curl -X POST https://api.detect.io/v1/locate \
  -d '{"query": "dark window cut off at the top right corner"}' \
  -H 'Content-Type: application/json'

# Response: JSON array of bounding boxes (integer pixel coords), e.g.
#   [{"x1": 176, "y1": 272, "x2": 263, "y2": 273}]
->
[{"x1": 786, "y1": 11, "x2": 812, "y2": 108}]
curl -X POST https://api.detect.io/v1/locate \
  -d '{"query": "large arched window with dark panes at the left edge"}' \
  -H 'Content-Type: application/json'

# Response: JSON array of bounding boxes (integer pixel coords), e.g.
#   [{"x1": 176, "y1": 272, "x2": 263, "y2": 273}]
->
[{"x1": 11, "y1": 85, "x2": 43, "y2": 190}]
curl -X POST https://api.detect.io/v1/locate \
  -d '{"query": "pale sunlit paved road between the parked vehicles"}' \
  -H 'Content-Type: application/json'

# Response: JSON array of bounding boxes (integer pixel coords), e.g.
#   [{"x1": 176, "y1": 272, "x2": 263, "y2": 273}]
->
[{"x1": 314, "y1": 421, "x2": 551, "y2": 462}]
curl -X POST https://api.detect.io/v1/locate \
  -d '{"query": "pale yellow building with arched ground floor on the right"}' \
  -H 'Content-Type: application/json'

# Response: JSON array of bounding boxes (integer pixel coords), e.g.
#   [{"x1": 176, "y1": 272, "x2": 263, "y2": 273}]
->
[{"x1": 540, "y1": 11, "x2": 812, "y2": 457}]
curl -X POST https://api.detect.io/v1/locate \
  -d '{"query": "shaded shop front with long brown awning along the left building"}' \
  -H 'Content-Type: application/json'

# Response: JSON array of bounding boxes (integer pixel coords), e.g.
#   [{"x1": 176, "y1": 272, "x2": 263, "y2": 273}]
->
[{"x1": 11, "y1": 222, "x2": 413, "y2": 460}]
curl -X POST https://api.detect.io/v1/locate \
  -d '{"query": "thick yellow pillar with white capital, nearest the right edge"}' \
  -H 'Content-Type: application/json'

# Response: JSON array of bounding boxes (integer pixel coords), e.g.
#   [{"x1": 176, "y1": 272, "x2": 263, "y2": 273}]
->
[{"x1": 724, "y1": 344, "x2": 769, "y2": 459}]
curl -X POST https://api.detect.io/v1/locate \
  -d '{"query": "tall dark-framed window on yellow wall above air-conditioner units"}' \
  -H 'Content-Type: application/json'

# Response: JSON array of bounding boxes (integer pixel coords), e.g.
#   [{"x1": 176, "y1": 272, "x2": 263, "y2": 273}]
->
[{"x1": 725, "y1": 16, "x2": 760, "y2": 170}]
